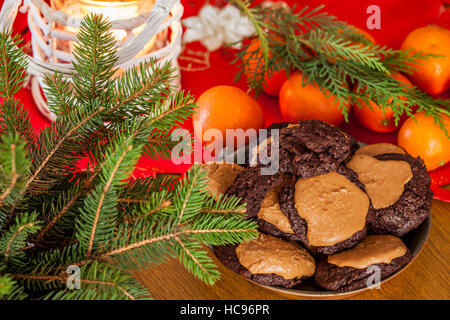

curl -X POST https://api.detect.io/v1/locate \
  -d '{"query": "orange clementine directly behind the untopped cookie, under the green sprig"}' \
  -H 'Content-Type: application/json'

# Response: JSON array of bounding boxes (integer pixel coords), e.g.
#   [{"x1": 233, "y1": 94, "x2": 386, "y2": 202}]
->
[{"x1": 279, "y1": 72, "x2": 350, "y2": 125}]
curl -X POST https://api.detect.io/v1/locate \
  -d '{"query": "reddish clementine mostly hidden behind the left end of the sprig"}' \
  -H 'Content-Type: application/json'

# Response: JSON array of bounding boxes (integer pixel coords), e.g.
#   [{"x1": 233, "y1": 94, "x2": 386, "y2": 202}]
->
[{"x1": 244, "y1": 39, "x2": 287, "y2": 96}]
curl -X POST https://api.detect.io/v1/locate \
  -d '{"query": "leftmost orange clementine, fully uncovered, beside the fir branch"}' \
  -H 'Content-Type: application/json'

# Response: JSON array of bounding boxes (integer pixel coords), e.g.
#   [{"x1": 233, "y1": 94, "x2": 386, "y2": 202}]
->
[{"x1": 192, "y1": 86, "x2": 264, "y2": 148}]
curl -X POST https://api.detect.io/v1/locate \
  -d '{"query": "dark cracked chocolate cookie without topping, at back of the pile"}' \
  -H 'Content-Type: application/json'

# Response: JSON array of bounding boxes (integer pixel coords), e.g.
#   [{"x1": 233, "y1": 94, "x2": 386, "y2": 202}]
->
[{"x1": 268, "y1": 120, "x2": 357, "y2": 178}]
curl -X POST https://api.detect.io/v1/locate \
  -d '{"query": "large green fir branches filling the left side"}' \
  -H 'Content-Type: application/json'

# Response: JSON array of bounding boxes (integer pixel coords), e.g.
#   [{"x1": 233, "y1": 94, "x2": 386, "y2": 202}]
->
[{"x1": 0, "y1": 15, "x2": 257, "y2": 299}]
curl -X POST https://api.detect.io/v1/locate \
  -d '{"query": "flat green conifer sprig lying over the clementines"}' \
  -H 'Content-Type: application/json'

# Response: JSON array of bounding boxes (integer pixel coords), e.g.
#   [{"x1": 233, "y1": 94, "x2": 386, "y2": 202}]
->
[{"x1": 229, "y1": 0, "x2": 450, "y2": 136}]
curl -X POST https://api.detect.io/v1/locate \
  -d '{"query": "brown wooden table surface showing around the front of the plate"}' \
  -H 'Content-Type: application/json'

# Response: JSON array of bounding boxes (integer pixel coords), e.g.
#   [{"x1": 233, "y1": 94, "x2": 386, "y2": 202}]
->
[{"x1": 137, "y1": 200, "x2": 450, "y2": 300}]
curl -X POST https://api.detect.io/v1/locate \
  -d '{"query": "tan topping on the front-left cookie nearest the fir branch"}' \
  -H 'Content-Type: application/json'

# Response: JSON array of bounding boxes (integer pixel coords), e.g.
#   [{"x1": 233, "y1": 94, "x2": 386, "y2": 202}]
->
[{"x1": 236, "y1": 233, "x2": 316, "y2": 279}]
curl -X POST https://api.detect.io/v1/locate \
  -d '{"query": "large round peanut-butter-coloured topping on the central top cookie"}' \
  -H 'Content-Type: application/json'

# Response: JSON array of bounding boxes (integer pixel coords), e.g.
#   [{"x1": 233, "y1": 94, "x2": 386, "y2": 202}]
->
[{"x1": 294, "y1": 172, "x2": 370, "y2": 246}]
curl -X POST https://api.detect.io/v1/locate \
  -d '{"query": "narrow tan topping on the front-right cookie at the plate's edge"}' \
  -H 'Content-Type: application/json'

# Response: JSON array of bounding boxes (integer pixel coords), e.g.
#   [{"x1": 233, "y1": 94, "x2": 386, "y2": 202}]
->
[{"x1": 328, "y1": 235, "x2": 406, "y2": 269}]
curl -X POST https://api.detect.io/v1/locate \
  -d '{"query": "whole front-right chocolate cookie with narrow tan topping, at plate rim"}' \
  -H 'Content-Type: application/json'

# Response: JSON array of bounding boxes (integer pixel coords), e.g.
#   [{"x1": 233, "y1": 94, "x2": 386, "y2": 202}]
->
[{"x1": 314, "y1": 235, "x2": 412, "y2": 292}]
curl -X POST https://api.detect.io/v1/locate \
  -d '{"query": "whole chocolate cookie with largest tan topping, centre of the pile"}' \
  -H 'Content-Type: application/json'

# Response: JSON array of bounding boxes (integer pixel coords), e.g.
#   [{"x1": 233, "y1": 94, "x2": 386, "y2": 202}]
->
[{"x1": 279, "y1": 166, "x2": 371, "y2": 254}]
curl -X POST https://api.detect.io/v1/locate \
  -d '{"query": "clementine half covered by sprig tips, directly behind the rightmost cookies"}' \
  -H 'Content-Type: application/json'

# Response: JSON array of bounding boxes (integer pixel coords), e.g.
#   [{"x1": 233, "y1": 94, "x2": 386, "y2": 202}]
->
[{"x1": 353, "y1": 73, "x2": 412, "y2": 132}]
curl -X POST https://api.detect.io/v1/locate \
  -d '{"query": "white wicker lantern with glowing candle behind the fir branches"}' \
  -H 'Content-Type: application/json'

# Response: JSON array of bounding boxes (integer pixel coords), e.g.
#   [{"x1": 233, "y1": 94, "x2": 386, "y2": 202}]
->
[{"x1": 0, "y1": 0, "x2": 183, "y2": 121}]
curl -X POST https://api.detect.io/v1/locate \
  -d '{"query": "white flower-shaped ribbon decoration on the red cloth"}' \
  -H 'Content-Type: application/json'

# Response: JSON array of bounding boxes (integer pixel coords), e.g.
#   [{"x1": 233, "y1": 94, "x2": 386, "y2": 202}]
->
[{"x1": 182, "y1": 5, "x2": 255, "y2": 51}]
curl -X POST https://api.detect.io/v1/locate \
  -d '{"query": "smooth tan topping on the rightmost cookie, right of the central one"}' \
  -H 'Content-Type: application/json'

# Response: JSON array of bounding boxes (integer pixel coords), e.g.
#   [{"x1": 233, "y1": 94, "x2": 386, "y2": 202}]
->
[{"x1": 347, "y1": 154, "x2": 413, "y2": 209}]
